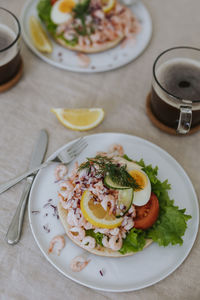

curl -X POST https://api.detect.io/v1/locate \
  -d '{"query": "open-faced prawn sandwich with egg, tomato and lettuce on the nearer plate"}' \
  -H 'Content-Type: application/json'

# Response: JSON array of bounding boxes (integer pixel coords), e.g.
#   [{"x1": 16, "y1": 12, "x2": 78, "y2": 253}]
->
[{"x1": 56, "y1": 145, "x2": 191, "y2": 257}]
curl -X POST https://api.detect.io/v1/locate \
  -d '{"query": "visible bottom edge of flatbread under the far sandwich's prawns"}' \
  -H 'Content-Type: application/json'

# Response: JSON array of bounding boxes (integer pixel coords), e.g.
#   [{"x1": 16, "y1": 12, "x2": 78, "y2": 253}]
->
[{"x1": 56, "y1": 35, "x2": 124, "y2": 54}]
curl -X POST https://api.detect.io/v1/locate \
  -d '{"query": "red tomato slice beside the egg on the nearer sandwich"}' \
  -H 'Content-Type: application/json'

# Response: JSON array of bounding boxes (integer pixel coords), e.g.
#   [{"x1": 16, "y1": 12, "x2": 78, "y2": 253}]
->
[{"x1": 134, "y1": 193, "x2": 159, "y2": 229}]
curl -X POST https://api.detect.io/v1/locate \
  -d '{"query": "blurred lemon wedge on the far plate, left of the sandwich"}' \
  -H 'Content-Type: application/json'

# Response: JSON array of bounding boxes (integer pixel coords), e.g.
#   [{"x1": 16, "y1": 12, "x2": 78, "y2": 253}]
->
[{"x1": 29, "y1": 16, "x2": 52, "y2": 53}]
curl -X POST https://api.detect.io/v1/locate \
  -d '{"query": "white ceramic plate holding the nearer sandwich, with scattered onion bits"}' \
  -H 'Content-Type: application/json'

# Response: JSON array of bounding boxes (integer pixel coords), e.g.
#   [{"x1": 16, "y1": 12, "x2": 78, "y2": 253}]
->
[{"x1": 28, "y1": 133, "x2": 199, "y2": 292}]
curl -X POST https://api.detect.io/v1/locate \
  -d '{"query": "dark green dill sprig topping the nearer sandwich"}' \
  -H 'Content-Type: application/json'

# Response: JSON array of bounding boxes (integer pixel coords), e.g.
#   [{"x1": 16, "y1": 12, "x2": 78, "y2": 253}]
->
[{"x1": 79, "y1": 155, "x2": 140, "y2": 189}]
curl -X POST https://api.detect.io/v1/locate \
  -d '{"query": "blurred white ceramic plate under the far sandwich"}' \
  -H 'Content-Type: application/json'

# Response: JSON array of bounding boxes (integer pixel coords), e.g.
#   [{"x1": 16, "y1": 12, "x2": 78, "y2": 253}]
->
[{"x1": 21, "y1": 0, "x2": 152, "y2": 73}]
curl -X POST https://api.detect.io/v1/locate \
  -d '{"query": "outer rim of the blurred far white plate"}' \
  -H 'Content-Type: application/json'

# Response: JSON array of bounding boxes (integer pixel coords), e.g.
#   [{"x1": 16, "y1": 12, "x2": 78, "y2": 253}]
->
[{"x1": 20, "y1": 0, "x2": 153, "y2": 74}]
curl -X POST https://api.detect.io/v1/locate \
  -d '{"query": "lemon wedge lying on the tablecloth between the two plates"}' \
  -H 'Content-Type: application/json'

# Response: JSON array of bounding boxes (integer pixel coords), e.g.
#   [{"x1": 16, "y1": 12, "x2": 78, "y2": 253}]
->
[{"x1": 51, "y1": 108, "x2": 104, "y2": 130}]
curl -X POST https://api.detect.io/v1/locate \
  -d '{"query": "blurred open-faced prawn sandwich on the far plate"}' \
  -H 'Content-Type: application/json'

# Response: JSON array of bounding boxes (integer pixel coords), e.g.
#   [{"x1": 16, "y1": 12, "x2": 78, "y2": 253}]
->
[{"x1": 37, "y1": 0, "x2": 140, "y2": 53}]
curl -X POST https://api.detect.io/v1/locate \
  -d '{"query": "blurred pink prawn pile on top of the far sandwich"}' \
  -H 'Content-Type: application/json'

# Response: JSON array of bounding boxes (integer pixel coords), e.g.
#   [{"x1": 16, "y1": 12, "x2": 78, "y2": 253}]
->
[{"x1": 57, "y1": 0, "x2": 140, "y2": 48}]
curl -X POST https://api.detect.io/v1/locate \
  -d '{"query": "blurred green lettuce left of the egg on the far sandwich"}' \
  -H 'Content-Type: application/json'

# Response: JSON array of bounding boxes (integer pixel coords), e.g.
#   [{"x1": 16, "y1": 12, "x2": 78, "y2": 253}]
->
[{"x1": 37, "y1": 0, "x2": 57, "y2": 35}]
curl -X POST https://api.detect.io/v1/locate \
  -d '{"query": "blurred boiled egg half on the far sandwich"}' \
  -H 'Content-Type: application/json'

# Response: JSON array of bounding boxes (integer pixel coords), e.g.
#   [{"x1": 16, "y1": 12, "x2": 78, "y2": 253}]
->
[{"x1": 51, "y1": 0, "x2": 79, "y2": 24}]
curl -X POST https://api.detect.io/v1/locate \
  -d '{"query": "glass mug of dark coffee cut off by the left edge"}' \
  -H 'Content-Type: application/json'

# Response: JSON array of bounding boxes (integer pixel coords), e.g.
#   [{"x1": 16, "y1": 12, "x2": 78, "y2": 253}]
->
[{"x1": 0, "y1": 7, "x2": 22, "y2": 86}]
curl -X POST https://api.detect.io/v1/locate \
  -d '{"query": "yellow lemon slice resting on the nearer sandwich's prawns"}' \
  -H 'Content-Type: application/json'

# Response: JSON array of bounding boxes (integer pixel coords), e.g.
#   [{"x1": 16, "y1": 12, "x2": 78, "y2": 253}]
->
[{"x1": 81, "y1": 191, "x2": 123, "y2": 229}]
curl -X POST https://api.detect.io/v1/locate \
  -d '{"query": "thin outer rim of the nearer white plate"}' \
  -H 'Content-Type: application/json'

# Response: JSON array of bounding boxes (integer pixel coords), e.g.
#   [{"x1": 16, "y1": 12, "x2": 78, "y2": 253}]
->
[{"x1": 28, "y1": 132, "x2": 199, "y2": 293}]
